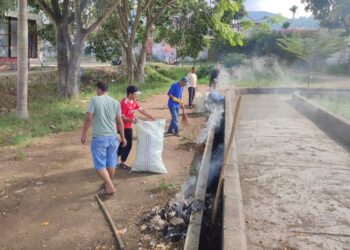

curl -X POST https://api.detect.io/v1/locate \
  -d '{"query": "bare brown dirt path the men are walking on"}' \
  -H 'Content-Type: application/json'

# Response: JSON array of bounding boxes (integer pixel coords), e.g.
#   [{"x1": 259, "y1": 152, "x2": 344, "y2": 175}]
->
[{"x1": 0, "y1": 88, "x2": 205, "y2": 249}]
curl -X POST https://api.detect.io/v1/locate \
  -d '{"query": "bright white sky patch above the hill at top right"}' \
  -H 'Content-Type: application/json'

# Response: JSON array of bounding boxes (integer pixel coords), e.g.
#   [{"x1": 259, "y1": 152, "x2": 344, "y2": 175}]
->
[{"x1": 245, "y1": 0, "x2": 310, "y2": 18}]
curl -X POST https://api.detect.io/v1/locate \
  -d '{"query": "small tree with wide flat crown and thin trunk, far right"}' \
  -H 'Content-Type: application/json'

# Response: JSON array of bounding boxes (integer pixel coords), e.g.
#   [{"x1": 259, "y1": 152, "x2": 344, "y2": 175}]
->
[{"x1": 277, "y1": 30, "x2": 346, "y2": 87}]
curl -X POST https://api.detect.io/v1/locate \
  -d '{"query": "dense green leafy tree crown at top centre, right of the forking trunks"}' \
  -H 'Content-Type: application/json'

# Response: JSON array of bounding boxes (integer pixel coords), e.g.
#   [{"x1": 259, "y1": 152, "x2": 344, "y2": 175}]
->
[{"x1": 156, "y1": 0, "x2": 249, "y2": 62}]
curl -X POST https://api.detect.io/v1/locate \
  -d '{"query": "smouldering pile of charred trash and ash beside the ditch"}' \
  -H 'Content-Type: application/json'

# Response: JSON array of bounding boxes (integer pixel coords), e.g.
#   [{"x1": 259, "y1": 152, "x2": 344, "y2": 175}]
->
[{"x1": 141, "y1": 199, "x2": 204, "y2": 249}]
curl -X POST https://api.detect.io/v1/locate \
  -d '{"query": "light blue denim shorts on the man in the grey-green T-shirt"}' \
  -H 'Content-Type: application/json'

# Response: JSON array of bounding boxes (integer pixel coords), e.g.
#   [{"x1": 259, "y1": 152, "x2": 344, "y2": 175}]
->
[{"x1": 90, "y1": 136, "x2": 118, "y2": 170}]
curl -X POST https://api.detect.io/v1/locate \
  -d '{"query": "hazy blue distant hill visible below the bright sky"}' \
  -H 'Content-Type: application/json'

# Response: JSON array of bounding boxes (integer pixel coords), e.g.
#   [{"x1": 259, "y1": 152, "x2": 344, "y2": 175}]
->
[{"x1": 248, "y1": 11, "x2": 320, "y2": 29}]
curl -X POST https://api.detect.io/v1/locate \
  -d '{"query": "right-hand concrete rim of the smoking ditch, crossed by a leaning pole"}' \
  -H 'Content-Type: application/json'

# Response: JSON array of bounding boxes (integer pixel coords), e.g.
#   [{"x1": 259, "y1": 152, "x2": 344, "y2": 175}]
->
[{"x1": 222, "y1": 90, "x2": 247, "y2": 250}]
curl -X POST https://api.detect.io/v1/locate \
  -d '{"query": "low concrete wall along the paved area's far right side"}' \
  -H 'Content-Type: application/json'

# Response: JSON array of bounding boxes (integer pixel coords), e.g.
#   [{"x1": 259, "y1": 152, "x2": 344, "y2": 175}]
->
[{"x1": 291, "y1": 94, "x2": 350, "y2": 147}]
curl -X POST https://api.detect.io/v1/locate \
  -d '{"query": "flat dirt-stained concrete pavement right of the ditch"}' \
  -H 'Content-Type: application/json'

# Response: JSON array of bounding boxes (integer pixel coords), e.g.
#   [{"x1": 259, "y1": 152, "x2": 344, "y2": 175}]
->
[{"x1": 237, "y1": 95, "x2": 350, "y2": 250}]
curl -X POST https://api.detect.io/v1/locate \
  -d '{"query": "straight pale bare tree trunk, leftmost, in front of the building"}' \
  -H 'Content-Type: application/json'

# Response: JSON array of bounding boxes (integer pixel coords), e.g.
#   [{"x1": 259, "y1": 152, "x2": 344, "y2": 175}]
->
[{"x1": 16, "y1": 0, "x2": 28, "y2": 118}]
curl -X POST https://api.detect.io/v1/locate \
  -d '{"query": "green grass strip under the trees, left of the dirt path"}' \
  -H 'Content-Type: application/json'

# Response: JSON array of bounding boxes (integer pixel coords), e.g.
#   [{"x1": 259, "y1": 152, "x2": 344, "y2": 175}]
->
[{"x1": 0, "y1": 64, "x2": 194, "y2": 146}]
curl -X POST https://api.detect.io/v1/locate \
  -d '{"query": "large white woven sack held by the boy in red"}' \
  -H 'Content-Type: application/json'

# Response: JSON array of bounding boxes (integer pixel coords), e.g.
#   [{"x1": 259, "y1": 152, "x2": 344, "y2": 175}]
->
[{"x1": 131, "y1": 119, "x2": 167, "y2": 174}]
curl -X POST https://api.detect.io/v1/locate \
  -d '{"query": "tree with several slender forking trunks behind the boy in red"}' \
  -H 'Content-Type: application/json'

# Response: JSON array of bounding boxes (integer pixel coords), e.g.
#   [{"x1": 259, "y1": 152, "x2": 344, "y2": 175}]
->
[{"x1": 88, "y1": 0, "x2": 178, "y2": 84}]
